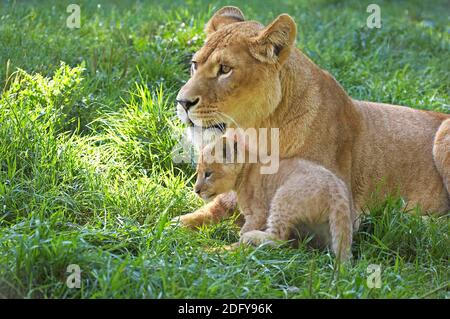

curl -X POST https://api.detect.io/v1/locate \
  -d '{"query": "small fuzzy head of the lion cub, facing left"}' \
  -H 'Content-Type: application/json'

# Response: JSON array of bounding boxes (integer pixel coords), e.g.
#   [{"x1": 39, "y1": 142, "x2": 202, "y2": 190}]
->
[{"x1": 194, "y1": 136, "x2": 245, "y2": 201}]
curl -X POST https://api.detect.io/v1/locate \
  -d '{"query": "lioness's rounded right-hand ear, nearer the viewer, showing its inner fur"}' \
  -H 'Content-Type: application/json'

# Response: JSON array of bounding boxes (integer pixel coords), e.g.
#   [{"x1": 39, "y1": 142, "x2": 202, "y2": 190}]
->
[{"x1": 250, "y1": 14, "x2": 297, "y2": 64}]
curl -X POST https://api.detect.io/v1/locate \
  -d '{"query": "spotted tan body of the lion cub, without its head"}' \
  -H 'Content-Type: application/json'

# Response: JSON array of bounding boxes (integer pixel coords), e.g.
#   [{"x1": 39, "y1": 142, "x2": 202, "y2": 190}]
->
[{"x1": 236, "y1": 158, "x2": 359, "y2": 260}]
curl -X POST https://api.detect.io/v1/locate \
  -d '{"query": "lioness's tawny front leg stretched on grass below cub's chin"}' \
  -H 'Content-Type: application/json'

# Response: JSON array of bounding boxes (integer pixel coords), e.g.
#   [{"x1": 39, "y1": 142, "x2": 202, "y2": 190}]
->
[{"x1": 173, "y1": 192, "x2": 237, "y2": 228}]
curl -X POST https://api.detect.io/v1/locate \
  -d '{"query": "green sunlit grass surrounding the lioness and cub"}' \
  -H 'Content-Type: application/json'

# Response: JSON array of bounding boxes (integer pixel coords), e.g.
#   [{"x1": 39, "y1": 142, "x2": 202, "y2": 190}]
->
[{"x1": 0, "y1": 0, "x2": 450, "y2": 298}]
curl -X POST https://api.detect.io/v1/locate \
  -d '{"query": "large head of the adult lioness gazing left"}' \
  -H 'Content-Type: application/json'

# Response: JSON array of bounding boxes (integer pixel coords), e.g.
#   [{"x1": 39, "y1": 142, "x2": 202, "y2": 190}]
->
[{"x1": 177, "y1": 7, "x2": 296, "y2": 128}]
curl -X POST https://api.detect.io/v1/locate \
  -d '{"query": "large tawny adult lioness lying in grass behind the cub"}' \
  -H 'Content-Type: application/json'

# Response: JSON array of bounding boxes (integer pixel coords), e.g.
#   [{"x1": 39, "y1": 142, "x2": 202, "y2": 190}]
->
[{"x1": 177, "y1": 7, "x2": 450, "y2": 227}]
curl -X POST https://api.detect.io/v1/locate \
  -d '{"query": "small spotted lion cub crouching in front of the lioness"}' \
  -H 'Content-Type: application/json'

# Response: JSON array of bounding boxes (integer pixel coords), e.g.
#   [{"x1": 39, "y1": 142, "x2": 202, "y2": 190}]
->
[{"x1": 195, "y1": 136, "x2": 356, "y2": 261}]
